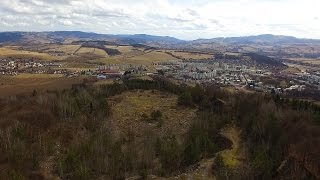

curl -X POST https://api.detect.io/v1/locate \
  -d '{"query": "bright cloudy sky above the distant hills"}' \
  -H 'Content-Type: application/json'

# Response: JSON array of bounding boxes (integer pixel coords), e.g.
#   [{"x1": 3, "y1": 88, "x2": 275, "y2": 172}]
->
[{"x1": 0, "y1": 0, "x2": 320, "y2": 40}]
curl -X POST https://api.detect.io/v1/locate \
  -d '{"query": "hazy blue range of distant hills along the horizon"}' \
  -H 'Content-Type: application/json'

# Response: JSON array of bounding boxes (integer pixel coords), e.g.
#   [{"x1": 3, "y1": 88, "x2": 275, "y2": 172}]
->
[{"x1": 0, "y1": 31, "x2": 320, "y2": 49}]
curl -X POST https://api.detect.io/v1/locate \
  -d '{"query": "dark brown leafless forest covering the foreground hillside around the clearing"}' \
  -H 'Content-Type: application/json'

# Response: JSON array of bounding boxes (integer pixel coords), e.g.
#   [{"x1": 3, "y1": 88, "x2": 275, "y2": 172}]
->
[{"x1": 0, "y1": 78, "x2": 320, "y2": 179}]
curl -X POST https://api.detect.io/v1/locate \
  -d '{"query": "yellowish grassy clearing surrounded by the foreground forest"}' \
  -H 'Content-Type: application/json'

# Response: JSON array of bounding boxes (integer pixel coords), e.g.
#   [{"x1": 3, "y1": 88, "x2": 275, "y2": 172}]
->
[{"x1": 109, "y1": 90, "x2": 196, "y2": 140}]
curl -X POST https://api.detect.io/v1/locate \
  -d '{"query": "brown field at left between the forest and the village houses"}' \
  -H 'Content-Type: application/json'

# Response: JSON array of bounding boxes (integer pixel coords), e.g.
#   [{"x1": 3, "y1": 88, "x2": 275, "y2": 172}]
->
[{"x1": 0, "y1": 74, "x2": 84, "y2": 97}]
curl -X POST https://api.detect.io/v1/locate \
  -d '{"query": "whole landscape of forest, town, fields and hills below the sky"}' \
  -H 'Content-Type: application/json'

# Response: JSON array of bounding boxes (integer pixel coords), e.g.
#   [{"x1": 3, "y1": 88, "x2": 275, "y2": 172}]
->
[{"x1": 0, "y1": 32, "x2": 320, "y2": 179}]
